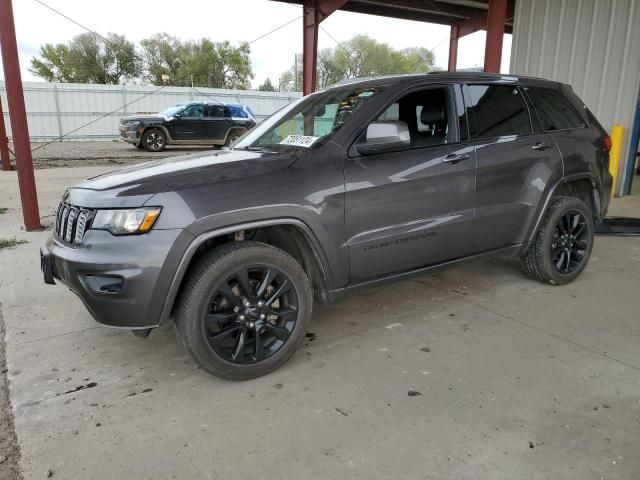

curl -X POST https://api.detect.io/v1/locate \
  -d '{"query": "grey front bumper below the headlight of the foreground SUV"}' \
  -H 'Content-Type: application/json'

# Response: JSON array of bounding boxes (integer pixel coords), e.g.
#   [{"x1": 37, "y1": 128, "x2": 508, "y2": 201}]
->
[{"x1": 40, "y1": 230, "x2": 193, "y2": 329}]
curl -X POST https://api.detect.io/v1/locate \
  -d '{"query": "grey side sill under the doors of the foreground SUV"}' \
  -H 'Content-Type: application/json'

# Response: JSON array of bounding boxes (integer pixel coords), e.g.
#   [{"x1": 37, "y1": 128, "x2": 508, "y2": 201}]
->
[{"x1": 325, "y1": 243, "x2": 528, "y2": 303}]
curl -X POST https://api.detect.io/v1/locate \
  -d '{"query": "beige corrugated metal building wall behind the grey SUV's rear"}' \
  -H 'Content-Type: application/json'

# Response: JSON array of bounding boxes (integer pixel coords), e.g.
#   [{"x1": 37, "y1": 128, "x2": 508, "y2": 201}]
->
[{"x1": 510, "y1": 0, "x2": 640, "y2": 195}]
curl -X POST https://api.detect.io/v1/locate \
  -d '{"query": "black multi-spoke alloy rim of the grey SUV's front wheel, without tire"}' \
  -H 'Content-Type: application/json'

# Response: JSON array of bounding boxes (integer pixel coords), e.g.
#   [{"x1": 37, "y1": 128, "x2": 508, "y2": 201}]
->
[{"x1": 203, "y1": 265, "x2": 298, "y2": 364}]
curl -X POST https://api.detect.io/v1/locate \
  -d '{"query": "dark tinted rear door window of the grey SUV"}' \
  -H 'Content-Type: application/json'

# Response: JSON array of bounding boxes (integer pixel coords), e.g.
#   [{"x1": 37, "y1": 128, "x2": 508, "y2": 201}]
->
[{"x1": 467, "y1": 85, "x2": 531, "y2": 138}]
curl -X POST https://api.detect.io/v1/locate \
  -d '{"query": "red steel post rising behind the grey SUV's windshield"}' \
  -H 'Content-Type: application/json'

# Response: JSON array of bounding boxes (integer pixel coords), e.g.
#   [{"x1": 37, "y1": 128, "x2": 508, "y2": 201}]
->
[{"x1": 302, "y1": 0, "x2": 347, "y2": 95}]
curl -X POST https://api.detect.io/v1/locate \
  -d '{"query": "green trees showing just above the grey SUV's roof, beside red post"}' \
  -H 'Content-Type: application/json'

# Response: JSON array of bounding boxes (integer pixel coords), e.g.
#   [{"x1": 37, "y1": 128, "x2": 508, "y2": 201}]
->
[{"x1": 280, "y1": 35, "x2": 435, "y2": 90}]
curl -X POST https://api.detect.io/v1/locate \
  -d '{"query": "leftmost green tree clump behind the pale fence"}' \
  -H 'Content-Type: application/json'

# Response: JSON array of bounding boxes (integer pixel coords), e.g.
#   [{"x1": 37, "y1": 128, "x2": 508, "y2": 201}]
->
[{"x1": 29, "y1": 33, "x2": 141, "y2": 84}]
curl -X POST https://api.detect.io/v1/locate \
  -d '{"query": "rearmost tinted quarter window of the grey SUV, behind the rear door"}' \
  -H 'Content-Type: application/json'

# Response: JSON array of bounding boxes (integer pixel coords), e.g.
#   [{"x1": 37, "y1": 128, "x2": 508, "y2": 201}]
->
[{"x1": 527, "y1": 87, "x2": 585, "y2": 131}]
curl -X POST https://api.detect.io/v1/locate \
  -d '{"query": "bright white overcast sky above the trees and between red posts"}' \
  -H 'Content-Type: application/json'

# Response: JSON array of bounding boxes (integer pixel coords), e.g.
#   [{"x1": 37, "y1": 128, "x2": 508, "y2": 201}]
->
[{"x1": 0, "y1": 0, "x2": 511, "y2": 87}]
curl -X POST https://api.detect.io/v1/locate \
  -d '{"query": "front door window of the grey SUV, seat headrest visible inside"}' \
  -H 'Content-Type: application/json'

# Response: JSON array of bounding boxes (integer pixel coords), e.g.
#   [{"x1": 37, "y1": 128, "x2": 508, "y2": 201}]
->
[{"x1": 376, "y1": 88, "x2": 451, "y2": 148}]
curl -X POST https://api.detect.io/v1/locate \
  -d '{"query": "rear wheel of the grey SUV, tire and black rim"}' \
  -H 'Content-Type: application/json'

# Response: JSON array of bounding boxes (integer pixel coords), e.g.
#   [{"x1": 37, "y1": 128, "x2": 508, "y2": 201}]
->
[{"x1": 521, "y1": 197, "x2": 594, "y2": 285}]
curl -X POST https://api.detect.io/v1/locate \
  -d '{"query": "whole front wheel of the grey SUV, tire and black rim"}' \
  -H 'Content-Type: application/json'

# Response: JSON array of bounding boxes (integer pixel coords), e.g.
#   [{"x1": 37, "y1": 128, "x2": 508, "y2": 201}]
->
[{"x1": 176, "y1": 241, "x2": 313, "y2": 380}]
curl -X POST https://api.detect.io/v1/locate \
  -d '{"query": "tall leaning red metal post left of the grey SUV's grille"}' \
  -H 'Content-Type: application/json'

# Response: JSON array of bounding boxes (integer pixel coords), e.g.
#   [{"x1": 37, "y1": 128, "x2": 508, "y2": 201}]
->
[{"x1": 0, "y1": 0, "x2": 41, "y2": 232}]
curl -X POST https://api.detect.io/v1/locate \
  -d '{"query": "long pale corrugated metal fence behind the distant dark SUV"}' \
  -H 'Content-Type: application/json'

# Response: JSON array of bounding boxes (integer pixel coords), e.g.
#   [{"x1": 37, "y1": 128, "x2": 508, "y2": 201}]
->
[{"x1": 0, "y1": 81, "x2": 300, "y2": 142}]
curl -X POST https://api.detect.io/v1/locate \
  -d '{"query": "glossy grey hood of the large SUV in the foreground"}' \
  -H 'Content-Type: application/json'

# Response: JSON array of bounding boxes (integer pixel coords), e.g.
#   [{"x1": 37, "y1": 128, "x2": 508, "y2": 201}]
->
[{"x1": 69, "y1": 150, "x2": 297, "y2": 208}]
